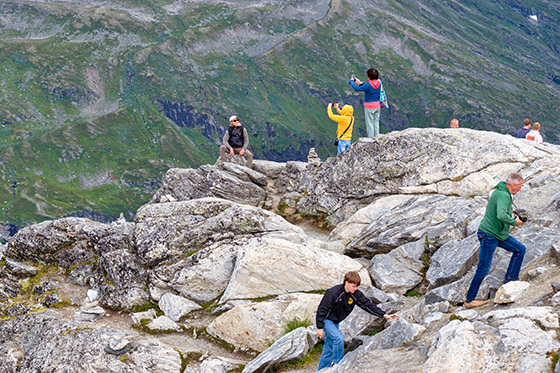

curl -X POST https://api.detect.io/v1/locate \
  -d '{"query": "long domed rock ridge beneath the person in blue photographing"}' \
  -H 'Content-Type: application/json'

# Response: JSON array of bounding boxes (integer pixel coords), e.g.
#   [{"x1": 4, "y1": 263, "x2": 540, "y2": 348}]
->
[{"x1": 298, "y1": 128, "x2": 560, "y2": 223}]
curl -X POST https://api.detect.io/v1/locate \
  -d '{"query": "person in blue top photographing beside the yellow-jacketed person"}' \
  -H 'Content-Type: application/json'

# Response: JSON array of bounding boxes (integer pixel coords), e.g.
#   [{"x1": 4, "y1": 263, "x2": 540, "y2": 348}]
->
[{"x1": 349, "y1": 68, "x2": 387, "y2": 137}]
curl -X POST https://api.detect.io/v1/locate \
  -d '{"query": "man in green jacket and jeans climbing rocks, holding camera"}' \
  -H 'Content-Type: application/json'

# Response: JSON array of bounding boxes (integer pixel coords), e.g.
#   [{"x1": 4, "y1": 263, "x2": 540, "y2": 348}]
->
[{"x1": 465, "y1": 173, "x2": 526, "y2": 308}]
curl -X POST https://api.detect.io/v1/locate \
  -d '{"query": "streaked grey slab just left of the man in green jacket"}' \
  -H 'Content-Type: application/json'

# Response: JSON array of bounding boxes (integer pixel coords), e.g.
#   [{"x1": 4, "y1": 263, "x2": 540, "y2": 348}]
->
[{"x1": 344, "y1": 195, "x2": 485, "y2": 258}]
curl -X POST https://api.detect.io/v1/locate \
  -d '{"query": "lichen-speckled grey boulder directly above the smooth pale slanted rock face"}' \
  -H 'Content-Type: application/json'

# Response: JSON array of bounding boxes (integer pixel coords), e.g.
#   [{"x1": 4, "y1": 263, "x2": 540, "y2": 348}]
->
[{"x1": 136, "y1": 198, "x2": 304, "y2": 266}]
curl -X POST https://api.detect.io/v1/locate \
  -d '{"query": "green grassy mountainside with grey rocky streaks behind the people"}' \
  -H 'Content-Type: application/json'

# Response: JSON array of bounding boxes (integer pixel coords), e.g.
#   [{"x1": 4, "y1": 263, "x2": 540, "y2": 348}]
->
[{"x1": 0, "y1": 0, "x2": 560, "y2": 225}]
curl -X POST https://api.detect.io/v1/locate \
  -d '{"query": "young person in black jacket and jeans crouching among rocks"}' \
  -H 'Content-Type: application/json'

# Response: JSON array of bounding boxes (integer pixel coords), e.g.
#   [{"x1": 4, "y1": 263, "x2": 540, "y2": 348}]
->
[{"x1": 316, "y1": 271, "x2": 398, "y2": 370}]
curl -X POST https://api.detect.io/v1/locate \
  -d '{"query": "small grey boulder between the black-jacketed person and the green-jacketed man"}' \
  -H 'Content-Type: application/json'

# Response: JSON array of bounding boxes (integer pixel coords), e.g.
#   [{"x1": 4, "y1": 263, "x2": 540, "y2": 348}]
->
[{"x1": 368, "y1": 240, "x2": 427, "y2": 294}]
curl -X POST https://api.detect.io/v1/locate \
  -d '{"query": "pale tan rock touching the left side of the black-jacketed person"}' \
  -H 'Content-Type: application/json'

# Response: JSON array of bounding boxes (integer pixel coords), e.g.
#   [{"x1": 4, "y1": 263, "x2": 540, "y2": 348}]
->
[{"x1": 207, "y1": 293, "x2": 323, "y2": 352}]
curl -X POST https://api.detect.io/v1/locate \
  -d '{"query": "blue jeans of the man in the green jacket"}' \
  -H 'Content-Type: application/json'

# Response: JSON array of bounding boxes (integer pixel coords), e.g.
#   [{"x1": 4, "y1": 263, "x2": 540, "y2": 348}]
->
[{"x1": 466, "y1": 229, "x2": 526, "y2": 302}]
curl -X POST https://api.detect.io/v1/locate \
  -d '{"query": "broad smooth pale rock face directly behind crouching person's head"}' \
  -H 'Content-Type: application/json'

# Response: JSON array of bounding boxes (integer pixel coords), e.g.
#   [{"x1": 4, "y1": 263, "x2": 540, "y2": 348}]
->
[{"x1": 220, "y1": 238, "x2": 371, "y2": 303}]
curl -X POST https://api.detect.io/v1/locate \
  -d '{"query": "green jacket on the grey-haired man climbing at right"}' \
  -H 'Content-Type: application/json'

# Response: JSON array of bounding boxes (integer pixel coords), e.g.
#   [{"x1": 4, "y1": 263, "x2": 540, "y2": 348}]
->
[{"x1": 478, "y1": 181, "x2": 516, "y2": 241}]
